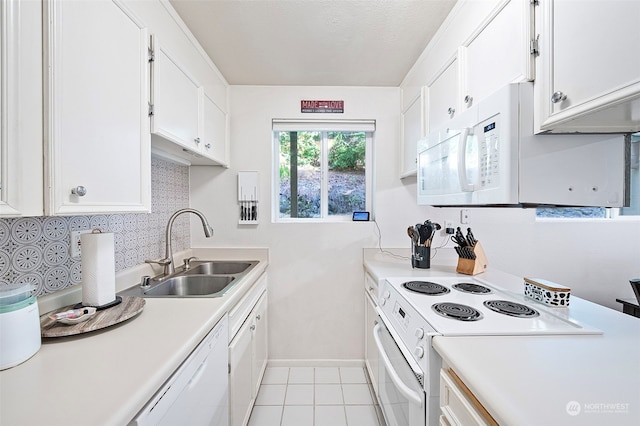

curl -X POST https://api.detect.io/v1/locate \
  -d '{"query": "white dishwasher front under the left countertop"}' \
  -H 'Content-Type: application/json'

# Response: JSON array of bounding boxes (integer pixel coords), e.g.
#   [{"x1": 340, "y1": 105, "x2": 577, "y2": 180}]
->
[{"x1": 130, "y1": 315, "x2": 229, "y2": 426}]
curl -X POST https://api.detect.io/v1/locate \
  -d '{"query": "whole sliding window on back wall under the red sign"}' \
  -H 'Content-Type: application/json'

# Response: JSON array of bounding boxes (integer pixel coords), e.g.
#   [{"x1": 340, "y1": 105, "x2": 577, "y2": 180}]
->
[{"x1": 273, "y1": 120, "x2": 375, "y2": 221}]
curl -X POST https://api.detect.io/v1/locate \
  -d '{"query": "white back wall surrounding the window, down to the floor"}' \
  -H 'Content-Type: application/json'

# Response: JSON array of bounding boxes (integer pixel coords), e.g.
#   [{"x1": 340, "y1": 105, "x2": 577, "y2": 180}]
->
[{"x1": 191, "y1": 86, "x2": 433, "y2": 359}]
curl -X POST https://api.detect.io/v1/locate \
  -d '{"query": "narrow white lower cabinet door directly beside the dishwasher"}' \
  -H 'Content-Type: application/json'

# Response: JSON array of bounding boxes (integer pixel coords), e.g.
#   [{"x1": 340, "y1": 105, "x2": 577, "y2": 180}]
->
[{"x1": 229, "y1": 320, "x2": 254, "y2": 426}]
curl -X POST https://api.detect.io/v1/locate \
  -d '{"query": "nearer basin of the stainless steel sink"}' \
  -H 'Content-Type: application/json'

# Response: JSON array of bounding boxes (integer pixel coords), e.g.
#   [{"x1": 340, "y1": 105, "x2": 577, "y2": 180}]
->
[{"x1": 144, "y1": 275, "x2": 236, "y2": 297}]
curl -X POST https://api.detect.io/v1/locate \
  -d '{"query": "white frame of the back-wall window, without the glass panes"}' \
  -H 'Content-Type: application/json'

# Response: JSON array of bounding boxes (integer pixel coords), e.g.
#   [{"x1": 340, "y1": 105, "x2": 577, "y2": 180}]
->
[{"x1": 271, "y1": 119, "x2": 375, "y2": 223}]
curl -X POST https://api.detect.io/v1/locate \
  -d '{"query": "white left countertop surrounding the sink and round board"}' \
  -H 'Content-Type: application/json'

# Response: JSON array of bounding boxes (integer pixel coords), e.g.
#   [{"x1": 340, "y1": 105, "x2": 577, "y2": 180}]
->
[{"x1": 0, "y1": 249, "x2": 268, "y2": 426}]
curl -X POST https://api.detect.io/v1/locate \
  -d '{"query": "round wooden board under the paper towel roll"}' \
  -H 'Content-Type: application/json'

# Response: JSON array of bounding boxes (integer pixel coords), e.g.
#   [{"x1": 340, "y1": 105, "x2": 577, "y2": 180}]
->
[{"x1": 40, "y1": 296, "x2": 146, "y2": 337}]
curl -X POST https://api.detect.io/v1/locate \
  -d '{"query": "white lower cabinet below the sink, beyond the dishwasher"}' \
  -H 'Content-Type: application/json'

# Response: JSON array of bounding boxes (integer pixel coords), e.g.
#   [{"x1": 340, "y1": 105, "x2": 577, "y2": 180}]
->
[{"x1": 229, "y1": 277, "x2": 268, "y2": 426}]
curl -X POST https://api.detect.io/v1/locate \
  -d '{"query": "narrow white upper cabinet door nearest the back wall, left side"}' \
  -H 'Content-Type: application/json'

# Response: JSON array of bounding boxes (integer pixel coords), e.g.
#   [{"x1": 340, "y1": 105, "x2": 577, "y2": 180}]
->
[{"x1": 200, "y1": 91, "x2": 229, "y2": 165}]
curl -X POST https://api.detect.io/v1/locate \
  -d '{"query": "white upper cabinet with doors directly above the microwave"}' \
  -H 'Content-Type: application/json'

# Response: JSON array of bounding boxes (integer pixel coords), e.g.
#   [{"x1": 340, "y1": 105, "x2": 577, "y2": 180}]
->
[{"x1": 402, "y1": 0, "x2": 534, "y2": 135}]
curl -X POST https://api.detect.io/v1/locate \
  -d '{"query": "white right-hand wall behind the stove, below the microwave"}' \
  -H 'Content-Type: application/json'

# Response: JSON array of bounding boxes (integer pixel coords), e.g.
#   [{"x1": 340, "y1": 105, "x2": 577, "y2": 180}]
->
[{"x1": 443, "y1": 208, "x2": 640, "y2": 310}]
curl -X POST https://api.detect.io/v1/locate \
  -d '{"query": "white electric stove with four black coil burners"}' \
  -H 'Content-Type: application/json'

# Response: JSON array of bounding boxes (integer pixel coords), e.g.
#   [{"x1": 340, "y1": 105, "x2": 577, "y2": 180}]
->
[{"x1": 374, "y1": 276, "x2": 602, "y2": 426}]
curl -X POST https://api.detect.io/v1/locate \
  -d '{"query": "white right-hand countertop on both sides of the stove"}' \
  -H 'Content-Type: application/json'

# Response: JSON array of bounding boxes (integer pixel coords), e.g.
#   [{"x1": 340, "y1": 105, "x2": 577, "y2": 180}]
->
[{"x1": 364, "y1": 251, "x2": 640, "y2": 426}]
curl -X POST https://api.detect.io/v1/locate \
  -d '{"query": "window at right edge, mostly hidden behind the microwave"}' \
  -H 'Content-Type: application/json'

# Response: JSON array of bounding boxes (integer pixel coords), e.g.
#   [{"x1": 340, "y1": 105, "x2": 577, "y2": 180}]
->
[{"x1": 536, "y1": 133, "x2": 640, "y2": 219}]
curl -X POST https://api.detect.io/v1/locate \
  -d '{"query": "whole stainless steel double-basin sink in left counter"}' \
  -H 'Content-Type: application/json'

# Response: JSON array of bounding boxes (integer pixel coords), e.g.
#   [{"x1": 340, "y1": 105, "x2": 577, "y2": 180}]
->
[{"x1": 118, "y1": 260, "x2": 258, "y2": 298}]
